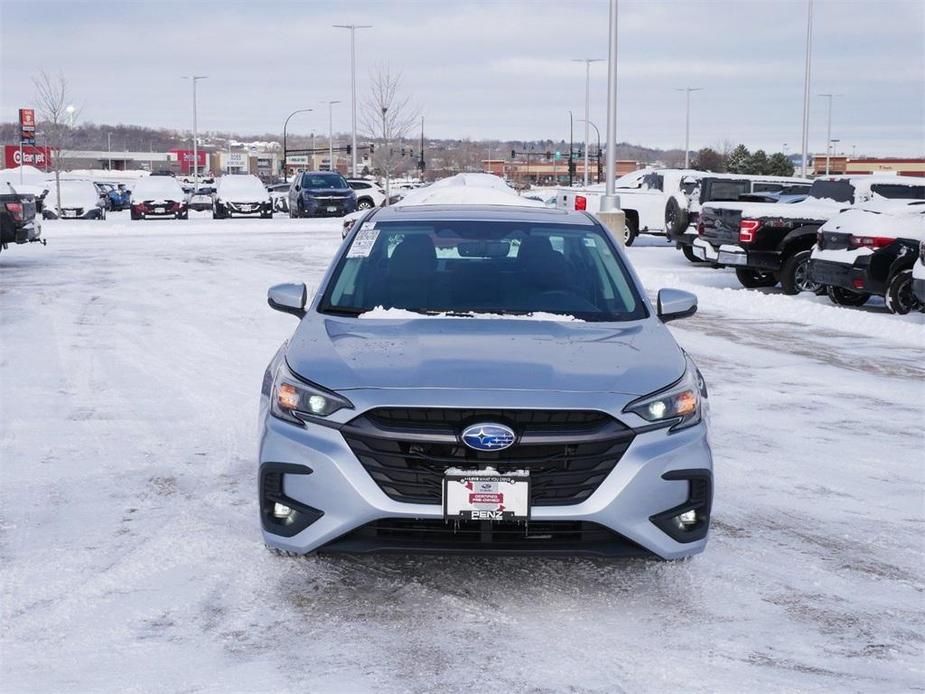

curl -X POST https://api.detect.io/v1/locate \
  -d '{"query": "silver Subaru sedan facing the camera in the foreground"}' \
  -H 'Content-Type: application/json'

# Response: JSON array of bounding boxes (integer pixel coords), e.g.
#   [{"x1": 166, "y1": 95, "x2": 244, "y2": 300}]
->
[{"x1": 258, "y1": 205, "x2": 713, "y2": 559}]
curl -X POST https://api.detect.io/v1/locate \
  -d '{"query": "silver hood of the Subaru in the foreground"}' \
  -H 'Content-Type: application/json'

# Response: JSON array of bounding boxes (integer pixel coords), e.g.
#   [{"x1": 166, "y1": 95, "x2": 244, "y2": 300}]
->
[{"x1": 286, "y1": 314, "x2": 685, "y2": 395}]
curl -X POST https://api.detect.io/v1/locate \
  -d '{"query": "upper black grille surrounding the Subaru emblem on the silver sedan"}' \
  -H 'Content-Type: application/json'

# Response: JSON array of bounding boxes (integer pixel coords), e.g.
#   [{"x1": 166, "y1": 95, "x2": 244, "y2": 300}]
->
[{"x1": 341, "y1": 408, "x2": 633, "y2": 506}]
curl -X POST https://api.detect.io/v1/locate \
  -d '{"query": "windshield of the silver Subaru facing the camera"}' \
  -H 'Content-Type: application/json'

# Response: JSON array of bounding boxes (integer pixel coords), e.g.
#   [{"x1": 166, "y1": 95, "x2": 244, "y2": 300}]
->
[{"x1": 321, "y1": 221, "x2": 648, "y2": 321}]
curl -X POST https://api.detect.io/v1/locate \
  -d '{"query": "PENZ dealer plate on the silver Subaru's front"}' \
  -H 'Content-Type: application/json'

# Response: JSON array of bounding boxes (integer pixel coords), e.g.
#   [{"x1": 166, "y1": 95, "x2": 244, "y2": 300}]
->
[{"x1": 443, "y1": 468, "x2": 530, "y2": 521}]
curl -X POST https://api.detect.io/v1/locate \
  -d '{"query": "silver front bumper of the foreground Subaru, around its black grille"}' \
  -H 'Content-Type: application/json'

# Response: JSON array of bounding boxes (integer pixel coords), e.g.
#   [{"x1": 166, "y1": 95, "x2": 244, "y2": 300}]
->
[{"x1": 258, "y1": 392, "x2": 713, "y2": 559}]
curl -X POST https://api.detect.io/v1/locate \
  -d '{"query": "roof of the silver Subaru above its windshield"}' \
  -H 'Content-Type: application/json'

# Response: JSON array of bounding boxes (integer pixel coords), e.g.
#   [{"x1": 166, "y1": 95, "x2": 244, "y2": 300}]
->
[{"x1": 374, "y1": 205, "x2": 594, "y2": 226}]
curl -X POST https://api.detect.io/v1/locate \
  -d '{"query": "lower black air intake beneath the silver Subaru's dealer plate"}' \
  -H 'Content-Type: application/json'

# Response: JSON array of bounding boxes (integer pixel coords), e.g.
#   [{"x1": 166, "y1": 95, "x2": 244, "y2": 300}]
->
[{"x1": 323, "y1": 518, "x2": 647, "y2": 556}]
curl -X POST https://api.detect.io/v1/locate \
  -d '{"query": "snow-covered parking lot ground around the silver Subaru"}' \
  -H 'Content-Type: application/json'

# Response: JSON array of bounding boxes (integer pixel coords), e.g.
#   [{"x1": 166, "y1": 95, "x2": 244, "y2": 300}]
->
[{"x1": 0, "y1": 213, "x2": 925, "y2": 693}]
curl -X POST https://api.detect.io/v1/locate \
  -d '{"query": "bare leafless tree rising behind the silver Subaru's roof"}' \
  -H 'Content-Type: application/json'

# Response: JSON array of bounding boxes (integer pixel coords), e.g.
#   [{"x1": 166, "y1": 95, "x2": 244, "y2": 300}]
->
[{"x1": 360, "y1": 63, "x2": 418, "y2": 201}]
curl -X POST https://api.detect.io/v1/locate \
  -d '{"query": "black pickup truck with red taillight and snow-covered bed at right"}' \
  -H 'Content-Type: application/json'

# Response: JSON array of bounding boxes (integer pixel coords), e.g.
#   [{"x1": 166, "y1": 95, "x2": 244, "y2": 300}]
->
[{"x1": 691, "y1": 176, "x2": 925, "y2": 294}]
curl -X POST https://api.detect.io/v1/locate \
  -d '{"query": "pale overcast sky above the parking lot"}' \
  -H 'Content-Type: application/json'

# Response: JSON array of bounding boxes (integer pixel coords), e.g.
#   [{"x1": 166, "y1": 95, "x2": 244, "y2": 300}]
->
[{"x1": 0, "y1": 0, "x2": 925, "y2": 156}]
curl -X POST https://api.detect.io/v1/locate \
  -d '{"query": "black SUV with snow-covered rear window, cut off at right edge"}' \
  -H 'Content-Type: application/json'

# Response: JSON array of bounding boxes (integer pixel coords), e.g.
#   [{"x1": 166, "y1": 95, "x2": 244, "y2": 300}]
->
[{"x1": 809, "y1": 200, "x2": 925, "y2": 314}]
